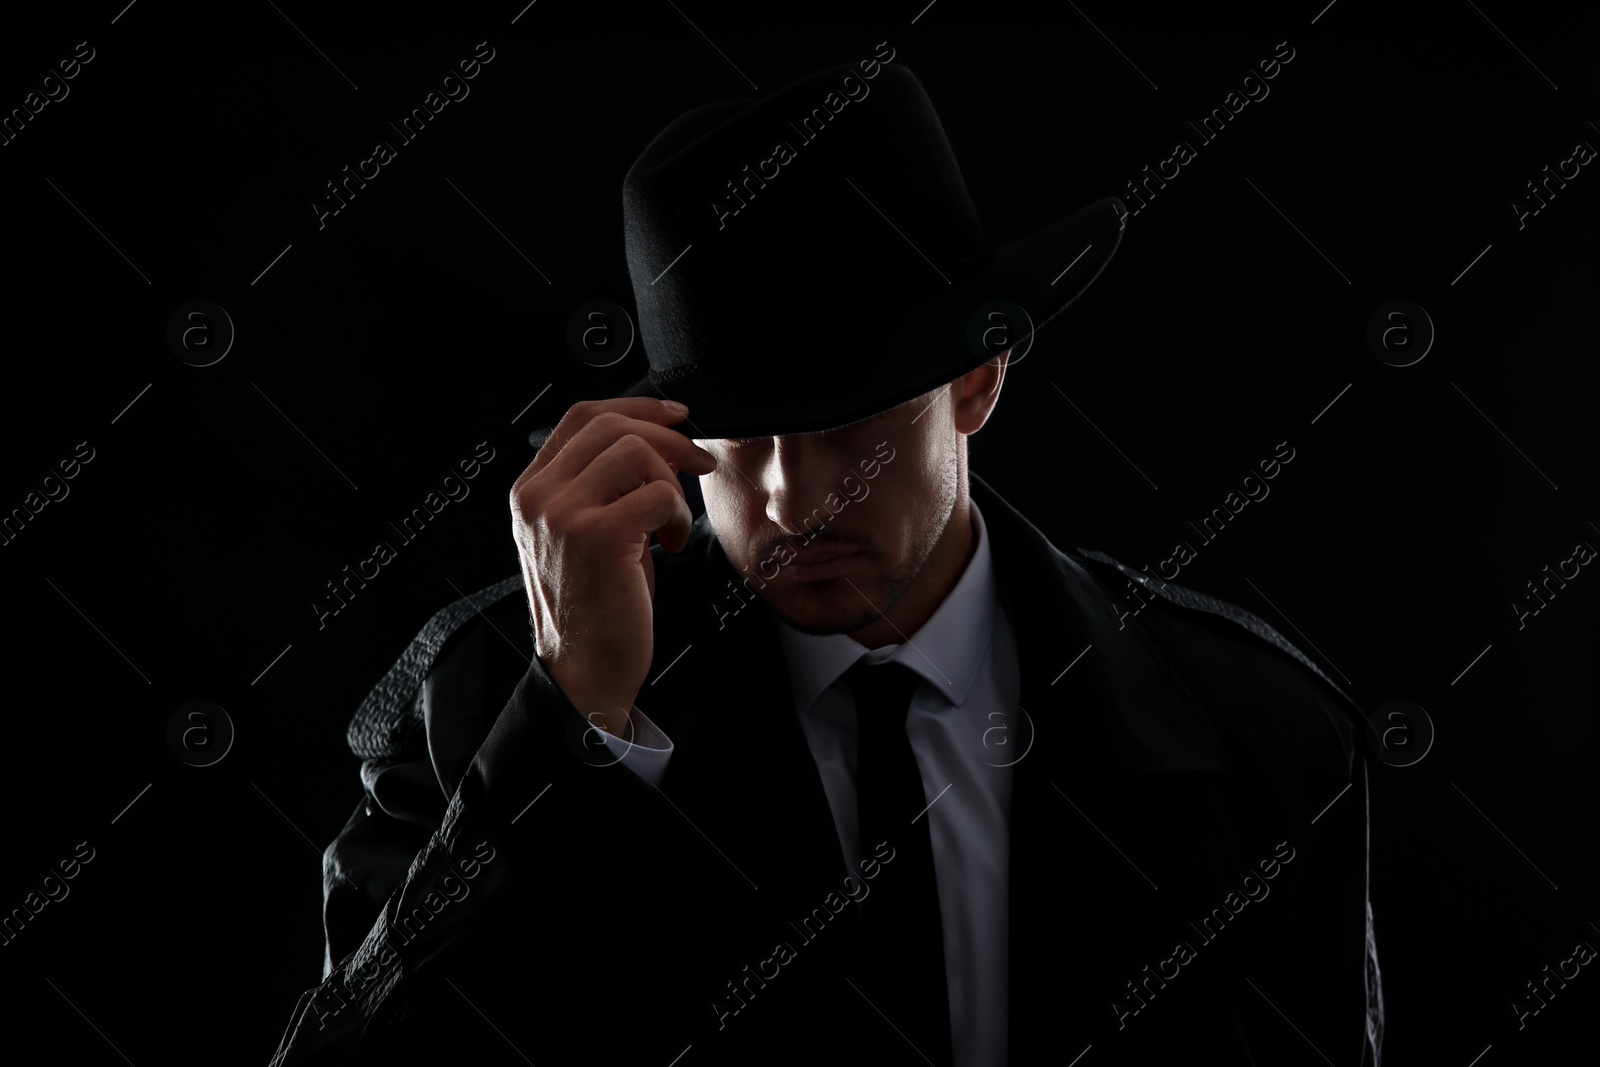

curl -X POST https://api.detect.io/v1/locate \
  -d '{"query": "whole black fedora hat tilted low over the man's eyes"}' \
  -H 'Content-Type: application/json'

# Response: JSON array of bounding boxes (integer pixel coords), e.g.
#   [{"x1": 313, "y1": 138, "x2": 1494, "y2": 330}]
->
[{"x1": 533, "y1": 61, "x2": 1125, "y2": 443}]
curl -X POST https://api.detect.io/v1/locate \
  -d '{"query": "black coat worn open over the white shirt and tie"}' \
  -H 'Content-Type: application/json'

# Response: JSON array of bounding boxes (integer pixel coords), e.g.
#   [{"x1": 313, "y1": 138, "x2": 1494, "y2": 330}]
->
[{"x1": 274, "y1": 477, "x2": 1382, "y2": 1067}]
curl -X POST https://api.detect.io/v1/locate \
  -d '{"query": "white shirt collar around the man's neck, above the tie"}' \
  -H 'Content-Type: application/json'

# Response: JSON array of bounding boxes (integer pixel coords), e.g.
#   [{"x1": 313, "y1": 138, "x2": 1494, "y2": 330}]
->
[{"x1": 773, "y1": 499, "x2": 1000, "y2": 712}]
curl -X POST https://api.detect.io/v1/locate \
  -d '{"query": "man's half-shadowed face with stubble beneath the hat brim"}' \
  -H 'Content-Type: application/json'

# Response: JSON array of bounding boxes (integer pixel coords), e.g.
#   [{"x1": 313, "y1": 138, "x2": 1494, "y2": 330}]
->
[{"x1": 699, "y1": 386, "x2": 966, "y2": 633}]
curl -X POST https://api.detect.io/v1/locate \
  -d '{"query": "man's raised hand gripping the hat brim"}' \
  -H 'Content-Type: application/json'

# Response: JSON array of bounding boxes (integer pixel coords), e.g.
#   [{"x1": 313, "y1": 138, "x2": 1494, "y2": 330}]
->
[{"x1": 510, "y1": 397, "x2": 717, "y2": 737}]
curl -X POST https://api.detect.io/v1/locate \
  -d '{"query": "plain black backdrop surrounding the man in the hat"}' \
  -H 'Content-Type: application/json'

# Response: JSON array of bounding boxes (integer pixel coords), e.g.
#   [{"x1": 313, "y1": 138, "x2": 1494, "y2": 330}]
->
[{"x1": 0, "y1": 0, "x2": 1600, "y2": 1067}]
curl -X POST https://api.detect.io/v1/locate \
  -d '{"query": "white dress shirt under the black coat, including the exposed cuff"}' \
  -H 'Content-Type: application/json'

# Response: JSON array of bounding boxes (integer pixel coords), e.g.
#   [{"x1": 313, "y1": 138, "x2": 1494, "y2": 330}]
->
[{"x1": 603, "y1": 502, "x2": 1032, "y2": 1067}]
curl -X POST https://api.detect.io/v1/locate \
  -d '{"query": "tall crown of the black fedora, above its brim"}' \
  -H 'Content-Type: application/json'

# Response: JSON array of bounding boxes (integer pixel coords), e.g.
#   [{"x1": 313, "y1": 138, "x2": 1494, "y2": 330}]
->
[{"x1": 622, "y1": 61, "x2": 994, "y2": 387}]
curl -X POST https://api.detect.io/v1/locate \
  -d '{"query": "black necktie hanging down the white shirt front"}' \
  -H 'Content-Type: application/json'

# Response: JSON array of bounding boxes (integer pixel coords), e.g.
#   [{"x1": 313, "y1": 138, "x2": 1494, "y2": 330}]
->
[{"x1": 845, "y1": 661, "x2": 950, "y2": 1067}]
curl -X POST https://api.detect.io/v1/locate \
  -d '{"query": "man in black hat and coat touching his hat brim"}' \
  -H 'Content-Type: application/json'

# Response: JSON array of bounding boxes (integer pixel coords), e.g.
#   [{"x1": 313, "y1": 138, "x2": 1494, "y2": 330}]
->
[{"x1": 274, "y1": 60, "x2": 1382, "y2": 1067}]
